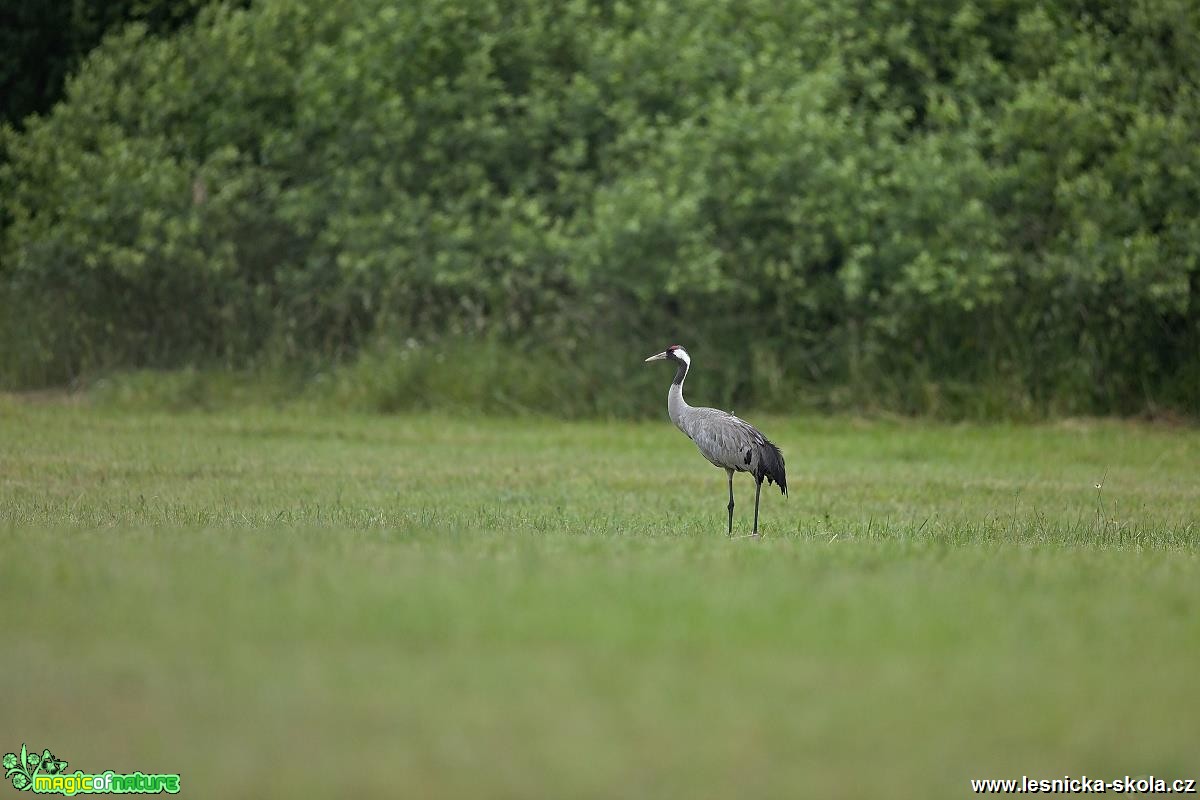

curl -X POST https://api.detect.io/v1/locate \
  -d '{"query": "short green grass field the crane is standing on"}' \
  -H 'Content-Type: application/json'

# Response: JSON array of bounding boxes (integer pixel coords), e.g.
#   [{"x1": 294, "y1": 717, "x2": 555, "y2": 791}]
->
[{"x1": 0, "y1": 397, "x2": 1200, "y2": 799}]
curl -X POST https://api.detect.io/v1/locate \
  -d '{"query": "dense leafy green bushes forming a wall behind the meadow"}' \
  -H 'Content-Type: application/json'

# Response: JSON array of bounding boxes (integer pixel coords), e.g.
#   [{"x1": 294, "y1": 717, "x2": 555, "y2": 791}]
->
[{"x1": 0, "y1": 0, "x2": 1200, "y2": 415}]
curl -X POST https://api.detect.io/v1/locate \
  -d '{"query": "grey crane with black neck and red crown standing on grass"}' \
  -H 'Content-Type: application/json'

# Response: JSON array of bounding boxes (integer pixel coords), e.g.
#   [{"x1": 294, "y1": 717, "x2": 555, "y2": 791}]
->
[{"x1": 646, "y1": 344, "x2": 787, "y2": 539}]
